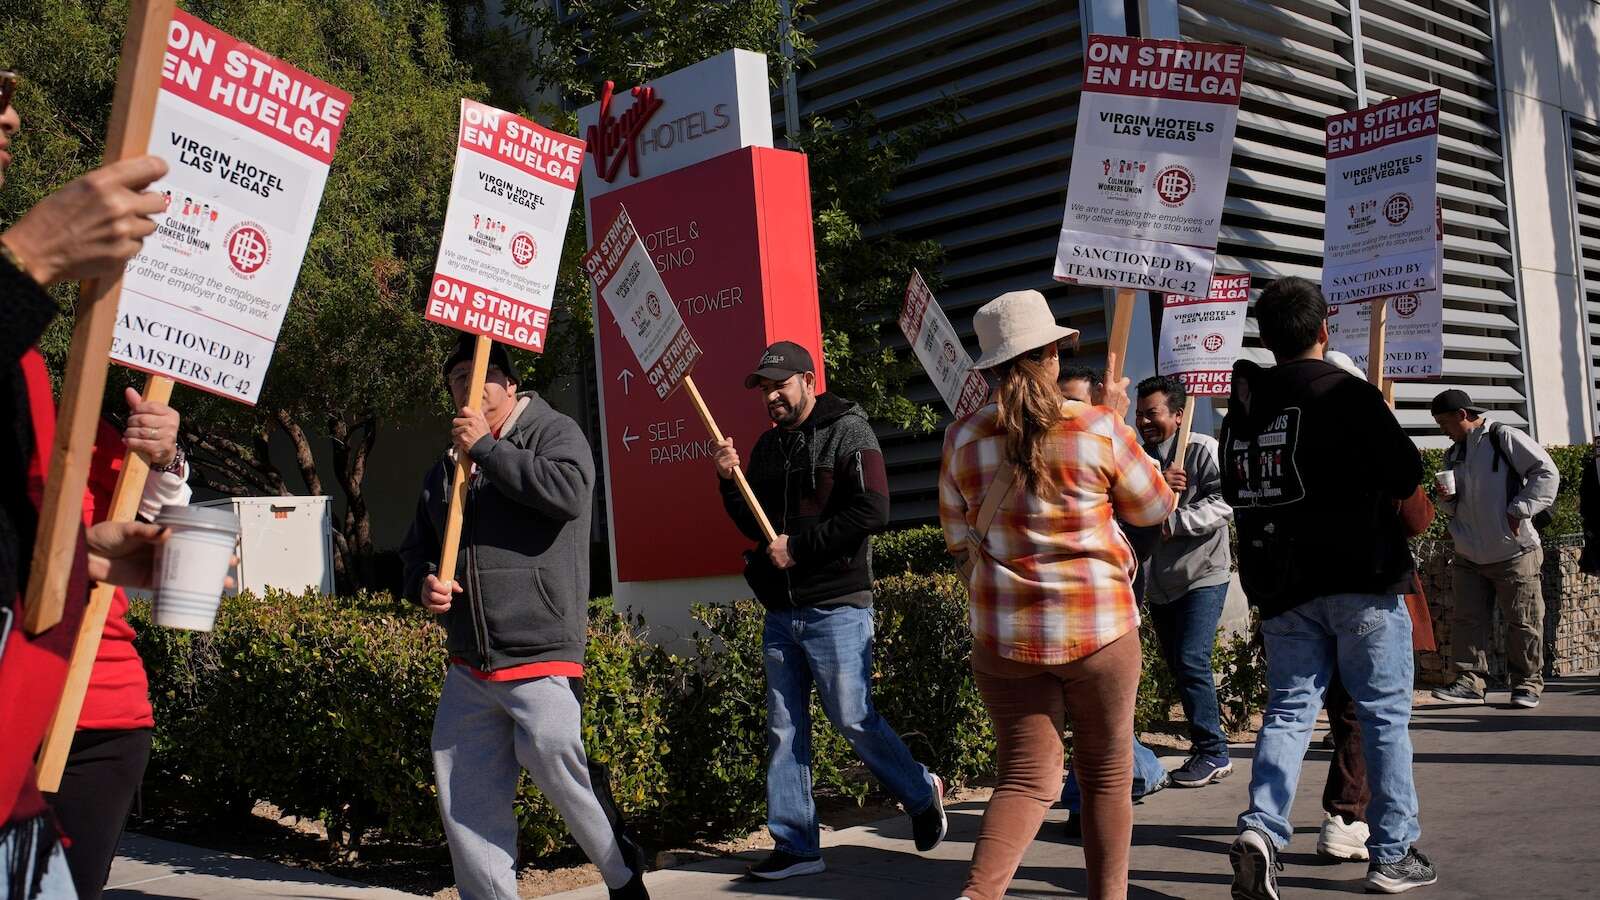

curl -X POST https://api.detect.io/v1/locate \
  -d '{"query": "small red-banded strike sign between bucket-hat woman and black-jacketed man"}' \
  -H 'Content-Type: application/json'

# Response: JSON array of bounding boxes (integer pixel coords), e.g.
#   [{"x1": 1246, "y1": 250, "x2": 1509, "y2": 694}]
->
[{"x1": 1157, "y1": 272, "x2": 1250, "y2": 397}]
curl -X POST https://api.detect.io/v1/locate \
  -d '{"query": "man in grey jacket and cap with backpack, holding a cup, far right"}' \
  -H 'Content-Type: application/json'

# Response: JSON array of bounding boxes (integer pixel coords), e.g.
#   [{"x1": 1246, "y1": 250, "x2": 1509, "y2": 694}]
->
[{"x1": 1430, "y1": 389, "x2": 1562, "y2": 709}]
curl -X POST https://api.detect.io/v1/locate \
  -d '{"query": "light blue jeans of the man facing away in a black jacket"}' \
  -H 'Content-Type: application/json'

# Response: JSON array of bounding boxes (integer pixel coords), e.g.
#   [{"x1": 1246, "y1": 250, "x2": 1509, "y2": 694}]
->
[{"x1": 1238, "y1": 594, "x2": 1422, "y2": 863}]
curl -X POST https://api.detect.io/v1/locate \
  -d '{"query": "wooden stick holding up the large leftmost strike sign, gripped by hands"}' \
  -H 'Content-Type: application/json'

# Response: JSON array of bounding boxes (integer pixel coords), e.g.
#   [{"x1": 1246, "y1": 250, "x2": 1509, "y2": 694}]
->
[{"x1": 37, "y1": 375, "x2": 173, "y2": 784}]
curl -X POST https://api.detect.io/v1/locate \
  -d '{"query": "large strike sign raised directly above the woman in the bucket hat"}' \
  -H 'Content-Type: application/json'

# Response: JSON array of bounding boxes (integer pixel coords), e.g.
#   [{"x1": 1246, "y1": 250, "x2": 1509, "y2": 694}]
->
[{"x1": 1054, "y1": 35, "x2": 1245, "y2": 295}]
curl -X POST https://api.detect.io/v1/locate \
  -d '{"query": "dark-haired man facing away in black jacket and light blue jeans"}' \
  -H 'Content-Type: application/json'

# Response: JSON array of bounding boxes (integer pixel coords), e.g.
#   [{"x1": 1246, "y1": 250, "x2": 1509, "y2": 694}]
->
[{"x1": 1219, "y1": 277, "x2": 1437, "y2": 900}]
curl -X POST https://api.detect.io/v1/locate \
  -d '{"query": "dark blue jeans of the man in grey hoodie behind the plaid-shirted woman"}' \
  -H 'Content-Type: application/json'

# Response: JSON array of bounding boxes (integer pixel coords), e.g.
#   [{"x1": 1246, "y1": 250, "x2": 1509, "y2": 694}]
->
[{"x1": 1150, "y1": 583, "x2": 1227, "y2": 757}]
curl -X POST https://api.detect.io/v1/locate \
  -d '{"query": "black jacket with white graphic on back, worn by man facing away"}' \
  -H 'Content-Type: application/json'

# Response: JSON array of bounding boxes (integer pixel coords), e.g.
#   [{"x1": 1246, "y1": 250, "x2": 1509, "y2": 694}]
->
[{"x1": 1219, "y1": 359, "x2": 1422, "y2": 618}]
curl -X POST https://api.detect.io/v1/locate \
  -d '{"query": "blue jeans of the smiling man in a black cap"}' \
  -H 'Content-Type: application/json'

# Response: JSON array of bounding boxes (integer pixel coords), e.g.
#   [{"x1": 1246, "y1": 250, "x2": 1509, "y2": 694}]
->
[{"x1": 762, "y1": 607, "x2": 934, "y2": 857}]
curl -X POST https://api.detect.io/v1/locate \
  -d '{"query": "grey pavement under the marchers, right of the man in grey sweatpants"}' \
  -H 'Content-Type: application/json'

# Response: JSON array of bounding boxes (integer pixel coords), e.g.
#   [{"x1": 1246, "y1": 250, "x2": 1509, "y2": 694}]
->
[{"x1": 557, "y1": 677, "x2": 1600, "y2": 900}]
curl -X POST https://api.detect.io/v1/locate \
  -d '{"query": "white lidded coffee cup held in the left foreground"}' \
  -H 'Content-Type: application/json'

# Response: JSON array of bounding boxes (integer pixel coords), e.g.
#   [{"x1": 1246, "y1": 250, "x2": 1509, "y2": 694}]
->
[{"x1": 155, "y1": 506, "x2": 238, "y2": 631}]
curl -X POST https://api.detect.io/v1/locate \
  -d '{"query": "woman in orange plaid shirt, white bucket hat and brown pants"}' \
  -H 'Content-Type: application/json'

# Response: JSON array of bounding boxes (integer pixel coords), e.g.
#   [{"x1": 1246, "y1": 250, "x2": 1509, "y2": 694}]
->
[{"x1": 939, "y1": 291, "x2": 1178, "y2": 900}]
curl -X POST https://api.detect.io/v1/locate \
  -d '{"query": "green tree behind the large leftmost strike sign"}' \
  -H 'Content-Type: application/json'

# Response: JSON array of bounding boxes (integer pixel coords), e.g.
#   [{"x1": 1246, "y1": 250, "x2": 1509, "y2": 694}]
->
[{"x1": 0, "y1": 0, "x2": 493, "y2": 583}]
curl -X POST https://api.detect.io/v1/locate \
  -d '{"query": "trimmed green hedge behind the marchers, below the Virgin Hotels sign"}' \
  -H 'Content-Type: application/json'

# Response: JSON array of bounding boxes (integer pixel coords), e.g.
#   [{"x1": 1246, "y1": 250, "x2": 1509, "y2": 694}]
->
[{"x1": 133, "y1": 563, "x2": 1259, "y2": 855}]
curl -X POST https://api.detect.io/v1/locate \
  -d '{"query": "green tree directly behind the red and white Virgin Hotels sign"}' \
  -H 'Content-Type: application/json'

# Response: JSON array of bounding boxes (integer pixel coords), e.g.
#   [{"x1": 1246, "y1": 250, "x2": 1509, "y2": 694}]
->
[{"x1": 502, "y1": 0, "x2": 952, "y2": 431}]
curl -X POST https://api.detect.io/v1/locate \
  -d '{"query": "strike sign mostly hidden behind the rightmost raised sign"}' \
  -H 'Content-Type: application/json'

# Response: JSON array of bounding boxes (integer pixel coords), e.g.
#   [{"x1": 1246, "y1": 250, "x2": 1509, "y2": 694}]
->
[{"x1": 1328, "y1": 199, "x2": 1445, "y2": 381}]
